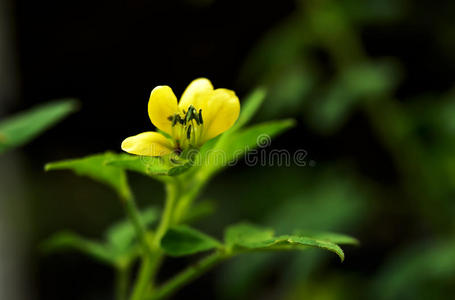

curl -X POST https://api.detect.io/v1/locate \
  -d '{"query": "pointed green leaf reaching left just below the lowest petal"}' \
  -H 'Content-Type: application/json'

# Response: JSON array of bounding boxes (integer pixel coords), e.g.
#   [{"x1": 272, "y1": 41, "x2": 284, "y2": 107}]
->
[{"x1": 45, "y1": 152, "x2": 130, "y2": 197}]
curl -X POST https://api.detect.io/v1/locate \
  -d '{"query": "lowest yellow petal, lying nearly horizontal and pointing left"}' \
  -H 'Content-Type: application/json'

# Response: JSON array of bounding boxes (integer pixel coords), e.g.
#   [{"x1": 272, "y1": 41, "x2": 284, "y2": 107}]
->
[{"x1": 122, "y1": 131, "x2": 173, "y2": 156}]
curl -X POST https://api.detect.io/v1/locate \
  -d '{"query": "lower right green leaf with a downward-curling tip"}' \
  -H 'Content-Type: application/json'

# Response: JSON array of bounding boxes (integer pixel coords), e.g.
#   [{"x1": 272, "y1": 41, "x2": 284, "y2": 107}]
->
[{"x1": 225, "y1": 223, "x2": 344, "y2": 261}]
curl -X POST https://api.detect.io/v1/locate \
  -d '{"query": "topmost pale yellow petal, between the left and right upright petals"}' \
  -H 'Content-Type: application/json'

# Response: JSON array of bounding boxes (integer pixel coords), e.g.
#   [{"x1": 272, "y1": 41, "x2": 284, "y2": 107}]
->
[{"x1": 179, "y1": 78, "x2": 213, "y2": 111}]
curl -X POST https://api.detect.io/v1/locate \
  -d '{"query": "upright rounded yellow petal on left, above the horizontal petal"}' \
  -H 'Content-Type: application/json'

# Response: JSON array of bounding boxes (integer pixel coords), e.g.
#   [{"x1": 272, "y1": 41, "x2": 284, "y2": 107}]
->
[{"x1": 148, "y1": 85, "x2": 178, "y2": 134}]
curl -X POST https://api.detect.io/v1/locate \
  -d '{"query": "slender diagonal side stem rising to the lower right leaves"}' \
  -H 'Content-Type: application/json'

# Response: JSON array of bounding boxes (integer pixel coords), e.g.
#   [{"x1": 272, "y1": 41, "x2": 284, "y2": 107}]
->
[{"x1": 148, "y1": 252, "x2": 228, "y2": 300}]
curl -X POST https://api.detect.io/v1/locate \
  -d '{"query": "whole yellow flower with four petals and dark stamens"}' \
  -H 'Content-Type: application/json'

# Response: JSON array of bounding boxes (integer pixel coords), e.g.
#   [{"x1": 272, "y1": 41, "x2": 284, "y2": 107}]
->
[{"x1": 122, "y1": 78, "x2": 240, "y2": 156}]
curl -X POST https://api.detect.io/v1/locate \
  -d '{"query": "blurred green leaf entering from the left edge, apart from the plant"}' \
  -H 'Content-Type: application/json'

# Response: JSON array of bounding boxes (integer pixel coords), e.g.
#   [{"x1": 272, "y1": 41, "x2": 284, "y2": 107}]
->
[{"x1": 0, "y1": 99, "x2": 76, "y2": 153}]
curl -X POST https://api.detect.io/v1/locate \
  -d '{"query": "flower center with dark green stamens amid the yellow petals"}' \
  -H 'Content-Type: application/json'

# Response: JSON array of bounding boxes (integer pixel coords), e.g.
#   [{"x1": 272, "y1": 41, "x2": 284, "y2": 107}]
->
[{"x1": 167, "y1": 105, "x2": 203, "y2": 152}]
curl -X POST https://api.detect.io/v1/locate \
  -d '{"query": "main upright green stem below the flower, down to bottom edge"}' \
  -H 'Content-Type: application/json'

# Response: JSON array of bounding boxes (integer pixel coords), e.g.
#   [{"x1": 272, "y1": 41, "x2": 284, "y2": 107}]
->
[{"x1": 130, "y1": 181, "x2": 178, "y2": 300}]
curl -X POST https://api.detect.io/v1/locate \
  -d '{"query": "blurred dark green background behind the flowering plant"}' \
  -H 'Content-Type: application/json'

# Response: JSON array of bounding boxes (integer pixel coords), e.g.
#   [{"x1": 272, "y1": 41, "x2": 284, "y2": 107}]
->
[{"x1": 0, "y1": 0, "x2": 455, "y2": 300}]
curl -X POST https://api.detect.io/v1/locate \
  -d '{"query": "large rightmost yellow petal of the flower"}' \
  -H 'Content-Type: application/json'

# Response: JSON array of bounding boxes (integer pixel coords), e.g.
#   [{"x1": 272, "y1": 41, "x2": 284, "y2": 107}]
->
[{"x1": 201, "y1": 89, "x2": 240, "y2": 143}]
